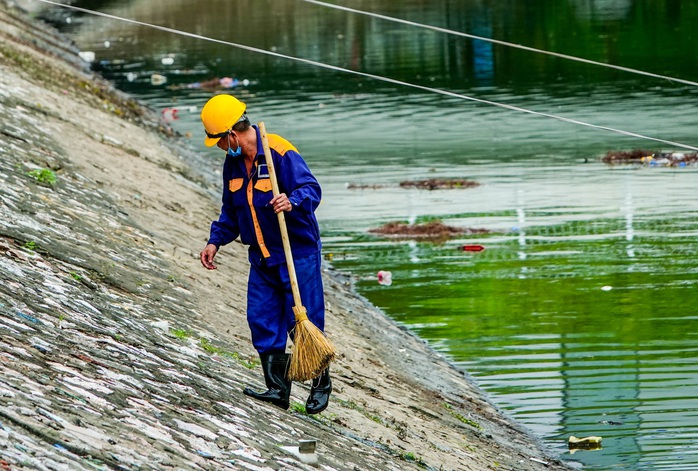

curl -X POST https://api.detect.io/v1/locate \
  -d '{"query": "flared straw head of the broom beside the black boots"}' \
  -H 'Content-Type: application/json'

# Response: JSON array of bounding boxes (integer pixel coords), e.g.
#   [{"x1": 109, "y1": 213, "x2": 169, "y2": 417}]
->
[{"x1": 287, "y1": 305, "x2": 336, "y2": 381}]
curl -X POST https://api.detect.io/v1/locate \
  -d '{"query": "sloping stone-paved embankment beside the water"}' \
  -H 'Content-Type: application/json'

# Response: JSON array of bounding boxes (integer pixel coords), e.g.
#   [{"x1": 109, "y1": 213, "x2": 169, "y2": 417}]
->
[{"x1": 0, "y1": 2, "x2": 565, "y2": 470}]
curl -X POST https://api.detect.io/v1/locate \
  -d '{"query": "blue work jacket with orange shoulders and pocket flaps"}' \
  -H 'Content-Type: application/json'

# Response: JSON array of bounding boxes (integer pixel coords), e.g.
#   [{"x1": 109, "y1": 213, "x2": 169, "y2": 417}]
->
[{"x1": 208, "y1": 126, "x2": 322, "y2": 266}]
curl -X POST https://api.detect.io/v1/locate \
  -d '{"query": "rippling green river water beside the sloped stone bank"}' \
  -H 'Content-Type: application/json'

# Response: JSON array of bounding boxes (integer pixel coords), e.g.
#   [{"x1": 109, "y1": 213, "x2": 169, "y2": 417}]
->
[{"x1": 53, "y1": 0, "x2": 698, "y2": 470}]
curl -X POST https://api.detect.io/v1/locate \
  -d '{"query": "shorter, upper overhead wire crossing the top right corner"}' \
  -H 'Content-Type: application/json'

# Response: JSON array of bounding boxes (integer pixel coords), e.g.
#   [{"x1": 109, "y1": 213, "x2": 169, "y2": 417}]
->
[{"x1": 300, "y1": 0, "x2": 698, "y2": 87}]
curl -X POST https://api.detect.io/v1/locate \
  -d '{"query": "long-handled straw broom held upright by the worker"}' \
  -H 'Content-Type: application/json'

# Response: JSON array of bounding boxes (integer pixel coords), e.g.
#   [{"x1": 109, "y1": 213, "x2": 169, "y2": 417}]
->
[{"x1": 258, "y1": 122, "x2": 335, "y2": 381}]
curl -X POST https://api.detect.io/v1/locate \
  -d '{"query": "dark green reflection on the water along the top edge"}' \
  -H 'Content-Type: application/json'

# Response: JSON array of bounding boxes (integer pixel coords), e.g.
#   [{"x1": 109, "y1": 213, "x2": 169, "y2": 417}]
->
[{"x1": 58, "y1": 0, "x2": 698, "y2": 92}]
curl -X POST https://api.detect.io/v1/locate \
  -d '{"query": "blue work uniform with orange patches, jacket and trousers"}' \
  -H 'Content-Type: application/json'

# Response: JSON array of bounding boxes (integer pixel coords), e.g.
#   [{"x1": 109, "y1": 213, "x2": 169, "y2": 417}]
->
[{"x1": 208, "y1": 126, "x2": 325, "y2": 355}]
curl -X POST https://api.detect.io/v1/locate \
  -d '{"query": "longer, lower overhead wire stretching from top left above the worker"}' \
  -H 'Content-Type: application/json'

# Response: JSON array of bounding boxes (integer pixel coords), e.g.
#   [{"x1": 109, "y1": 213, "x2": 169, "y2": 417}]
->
[{"x1": 31, "y1": 0, "x2": 698, "y2": 151}]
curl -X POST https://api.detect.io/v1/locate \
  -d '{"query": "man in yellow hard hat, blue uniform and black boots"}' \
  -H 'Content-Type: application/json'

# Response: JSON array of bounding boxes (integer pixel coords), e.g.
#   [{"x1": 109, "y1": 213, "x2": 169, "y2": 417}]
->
[{"x1": 200, "y1": 94, "x2": 332, "y2": 414}]
